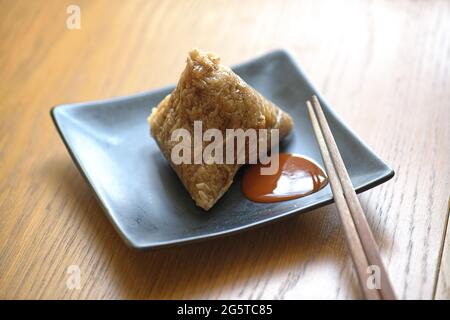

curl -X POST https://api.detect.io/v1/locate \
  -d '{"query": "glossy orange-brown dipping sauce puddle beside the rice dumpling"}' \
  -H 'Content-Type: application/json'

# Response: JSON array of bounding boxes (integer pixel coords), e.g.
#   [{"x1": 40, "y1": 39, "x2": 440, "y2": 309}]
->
[{"x1": 242, "y1": 153, "x2": 328, "y2": 202}]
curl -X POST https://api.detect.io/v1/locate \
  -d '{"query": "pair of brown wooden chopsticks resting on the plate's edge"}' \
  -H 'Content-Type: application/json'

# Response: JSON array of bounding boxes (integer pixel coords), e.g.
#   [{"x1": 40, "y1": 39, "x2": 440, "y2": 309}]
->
[{"x1": 306, "y1": 96, "x2": 395, "y2": 300}]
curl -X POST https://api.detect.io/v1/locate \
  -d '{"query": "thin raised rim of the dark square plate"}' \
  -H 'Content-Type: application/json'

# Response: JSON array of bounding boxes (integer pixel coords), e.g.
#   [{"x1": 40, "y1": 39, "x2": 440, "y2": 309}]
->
[{"x1": 50, "y1": 49, "x2": 395, "y2": 250}]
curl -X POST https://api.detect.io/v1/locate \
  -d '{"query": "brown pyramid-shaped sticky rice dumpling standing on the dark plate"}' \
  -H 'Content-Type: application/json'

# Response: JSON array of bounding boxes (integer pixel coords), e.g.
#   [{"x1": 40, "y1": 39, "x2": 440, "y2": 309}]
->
[{"x1": 148, "y1": 50, "x2": 292, "y2": 210}]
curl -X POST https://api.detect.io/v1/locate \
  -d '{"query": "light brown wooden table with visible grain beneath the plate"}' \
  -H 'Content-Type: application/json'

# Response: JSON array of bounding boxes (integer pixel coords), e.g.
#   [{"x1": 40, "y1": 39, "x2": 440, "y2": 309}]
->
[{"x1": 0, "y1": 0, "x2": 450, "y2": 299}]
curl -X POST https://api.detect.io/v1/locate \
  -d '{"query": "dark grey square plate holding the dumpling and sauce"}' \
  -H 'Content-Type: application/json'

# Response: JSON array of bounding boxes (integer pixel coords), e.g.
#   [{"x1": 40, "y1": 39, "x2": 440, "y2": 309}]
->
[{"x1": 51, "y1": 50, "x2": 394, "y2": 249}]
